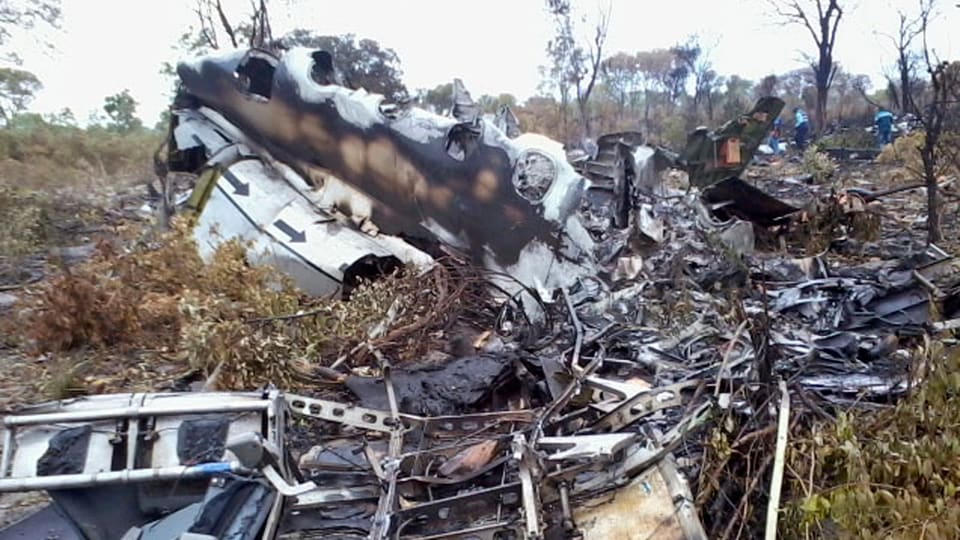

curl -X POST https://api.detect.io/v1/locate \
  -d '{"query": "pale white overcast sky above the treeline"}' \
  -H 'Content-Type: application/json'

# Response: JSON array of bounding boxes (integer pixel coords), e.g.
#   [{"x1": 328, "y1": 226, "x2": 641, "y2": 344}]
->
[{"x1": 10, "y1": 0, "x2": 960, "y2": 125}]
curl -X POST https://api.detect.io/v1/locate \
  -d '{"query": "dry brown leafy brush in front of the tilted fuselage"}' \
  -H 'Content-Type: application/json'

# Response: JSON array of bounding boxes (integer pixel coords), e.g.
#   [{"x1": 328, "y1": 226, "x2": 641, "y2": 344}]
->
[{"x1": 1, "y1": 216, "x2": 483, "y2": 397}]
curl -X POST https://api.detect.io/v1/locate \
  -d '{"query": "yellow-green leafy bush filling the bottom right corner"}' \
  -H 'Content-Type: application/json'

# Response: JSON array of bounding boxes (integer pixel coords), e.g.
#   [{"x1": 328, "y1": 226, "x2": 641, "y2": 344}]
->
[{"x1": 783, "y1": 346, "x2": 960, "y2": 540}]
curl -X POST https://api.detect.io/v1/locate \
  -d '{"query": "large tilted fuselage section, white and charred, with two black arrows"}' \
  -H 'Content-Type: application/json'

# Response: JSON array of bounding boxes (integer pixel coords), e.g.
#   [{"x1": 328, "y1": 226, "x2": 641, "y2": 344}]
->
[{"x1": 163, "y1": 48, "x2": 782, "y2": 300}]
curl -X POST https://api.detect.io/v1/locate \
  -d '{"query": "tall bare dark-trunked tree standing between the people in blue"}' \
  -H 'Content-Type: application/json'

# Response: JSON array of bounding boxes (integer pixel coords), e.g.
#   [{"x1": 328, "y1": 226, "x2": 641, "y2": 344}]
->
[{"x1": 768, "y1": 0, "x2": 843, "y2": 129}]
